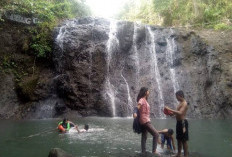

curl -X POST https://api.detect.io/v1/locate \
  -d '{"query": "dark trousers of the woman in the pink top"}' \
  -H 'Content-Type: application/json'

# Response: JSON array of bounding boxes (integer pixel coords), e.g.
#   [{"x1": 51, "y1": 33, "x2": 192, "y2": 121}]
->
[{"x1": 141, "y1": 122, "x2": 159, "y2": 153}]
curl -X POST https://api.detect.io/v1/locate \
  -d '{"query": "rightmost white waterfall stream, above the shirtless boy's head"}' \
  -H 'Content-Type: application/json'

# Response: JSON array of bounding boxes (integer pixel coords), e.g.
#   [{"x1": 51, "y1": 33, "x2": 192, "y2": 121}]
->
[{"x1": 166, "y1": 29, "x2": 179, "y2": 96}]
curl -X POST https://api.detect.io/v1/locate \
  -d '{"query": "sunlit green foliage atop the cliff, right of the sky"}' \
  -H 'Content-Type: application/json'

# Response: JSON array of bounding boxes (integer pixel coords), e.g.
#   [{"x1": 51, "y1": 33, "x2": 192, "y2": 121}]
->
[{"x1": 118, "y1": 0, "x2": 232, "y2": 29}]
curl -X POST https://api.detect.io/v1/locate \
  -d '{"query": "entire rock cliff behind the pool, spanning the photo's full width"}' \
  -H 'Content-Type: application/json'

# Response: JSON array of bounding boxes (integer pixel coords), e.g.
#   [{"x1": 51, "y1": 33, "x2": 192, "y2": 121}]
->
[{"x1": 0, "y1": 18, "x2": 232, "y2": 119}]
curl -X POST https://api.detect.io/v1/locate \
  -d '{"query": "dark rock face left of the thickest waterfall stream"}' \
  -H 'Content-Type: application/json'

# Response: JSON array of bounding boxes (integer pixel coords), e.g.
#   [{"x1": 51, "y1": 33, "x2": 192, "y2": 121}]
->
[{"x1": 54, "y1": 19, "x2": 110, "y2": 116}]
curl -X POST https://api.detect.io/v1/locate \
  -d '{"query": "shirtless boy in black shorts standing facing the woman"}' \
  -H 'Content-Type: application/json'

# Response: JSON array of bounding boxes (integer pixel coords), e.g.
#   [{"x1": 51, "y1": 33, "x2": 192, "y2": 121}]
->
[{"x1": 165, "y1": 90, "x2": 189, "y2": 157}]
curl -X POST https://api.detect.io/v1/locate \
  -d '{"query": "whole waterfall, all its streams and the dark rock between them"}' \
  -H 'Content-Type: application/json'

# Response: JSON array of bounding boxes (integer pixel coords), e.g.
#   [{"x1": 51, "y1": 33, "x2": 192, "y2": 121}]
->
[{"x1": 54, "y1": 18, "x2": 207, "y2": 118}]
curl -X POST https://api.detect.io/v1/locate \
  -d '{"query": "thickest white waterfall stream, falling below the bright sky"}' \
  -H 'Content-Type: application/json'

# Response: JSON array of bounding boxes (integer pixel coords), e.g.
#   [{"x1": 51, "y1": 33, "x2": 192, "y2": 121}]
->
[{"x1": 105, "y1": 20, "x2": 119, "y2": 117}]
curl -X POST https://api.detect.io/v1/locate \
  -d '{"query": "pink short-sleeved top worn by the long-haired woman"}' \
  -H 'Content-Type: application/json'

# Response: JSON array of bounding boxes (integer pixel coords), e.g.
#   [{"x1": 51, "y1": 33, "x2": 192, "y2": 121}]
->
[{"x1": 138, "y1": 98, "x2": 151, "y2": 124}]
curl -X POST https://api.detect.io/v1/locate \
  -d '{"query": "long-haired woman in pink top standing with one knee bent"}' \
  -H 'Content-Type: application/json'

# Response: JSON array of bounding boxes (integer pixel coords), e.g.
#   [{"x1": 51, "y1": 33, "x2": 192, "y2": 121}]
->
[{"x1": 137, "y1": 87, "x2": 160, "y2": 156}]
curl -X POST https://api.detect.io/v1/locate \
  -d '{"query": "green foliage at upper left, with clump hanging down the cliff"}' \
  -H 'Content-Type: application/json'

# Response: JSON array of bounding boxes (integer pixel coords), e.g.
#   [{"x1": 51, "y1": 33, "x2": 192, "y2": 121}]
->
[{"x1": 0, "y1": 0, "x2": 90, "y2": 57}]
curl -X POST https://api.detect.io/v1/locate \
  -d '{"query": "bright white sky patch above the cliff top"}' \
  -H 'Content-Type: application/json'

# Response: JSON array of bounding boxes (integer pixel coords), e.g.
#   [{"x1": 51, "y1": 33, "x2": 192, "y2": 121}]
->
[{"x1": 86, "y1": 0, "x2": 127, "y2": 18}]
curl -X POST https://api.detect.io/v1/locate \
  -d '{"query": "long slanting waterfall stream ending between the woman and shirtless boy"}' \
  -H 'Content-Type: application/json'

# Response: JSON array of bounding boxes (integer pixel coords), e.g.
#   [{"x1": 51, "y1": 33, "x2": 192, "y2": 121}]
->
[{"x1": 147, "y1": 27, "x2": 164, "y2": 117}]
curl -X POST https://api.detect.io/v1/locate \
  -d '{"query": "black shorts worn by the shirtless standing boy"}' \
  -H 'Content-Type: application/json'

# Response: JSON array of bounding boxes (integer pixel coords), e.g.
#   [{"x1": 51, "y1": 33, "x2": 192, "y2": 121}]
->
[{"x1": 176, "y1": 119, "x2": 189, "y2": 141}]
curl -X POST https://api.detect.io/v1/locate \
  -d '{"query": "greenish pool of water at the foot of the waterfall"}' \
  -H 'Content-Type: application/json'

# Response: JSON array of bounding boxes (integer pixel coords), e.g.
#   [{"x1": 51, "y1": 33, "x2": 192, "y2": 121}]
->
[{"x1": 0, "y1": 117, "x2": 232, "y2": 157}]
